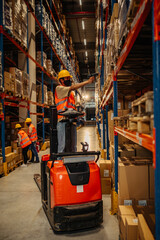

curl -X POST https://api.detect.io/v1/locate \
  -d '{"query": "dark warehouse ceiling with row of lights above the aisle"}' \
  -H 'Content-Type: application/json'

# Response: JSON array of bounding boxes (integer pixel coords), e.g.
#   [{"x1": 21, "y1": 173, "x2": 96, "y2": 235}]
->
[{"x1": 61, "y1": 0, "x2": 96, "y2": 81}]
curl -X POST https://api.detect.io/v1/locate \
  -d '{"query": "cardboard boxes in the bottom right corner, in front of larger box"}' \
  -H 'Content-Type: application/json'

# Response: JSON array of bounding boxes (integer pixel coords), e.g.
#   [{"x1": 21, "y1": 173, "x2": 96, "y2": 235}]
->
[{"x1": 118, "y1": 205, "x2": 155, "y2": 240}]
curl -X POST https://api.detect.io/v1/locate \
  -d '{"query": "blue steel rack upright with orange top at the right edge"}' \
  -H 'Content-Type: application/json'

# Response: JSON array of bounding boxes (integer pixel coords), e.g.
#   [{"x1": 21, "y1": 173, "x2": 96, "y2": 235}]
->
[{"x1": 152, "y1": 0, "x2": 160, "y2": 239}]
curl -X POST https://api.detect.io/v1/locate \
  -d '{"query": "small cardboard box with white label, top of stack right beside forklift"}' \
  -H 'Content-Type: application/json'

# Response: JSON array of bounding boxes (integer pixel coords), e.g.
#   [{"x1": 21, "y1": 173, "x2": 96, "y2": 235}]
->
[{"x1": 99, "y1": 160, "x2": 111, "y2": 178}]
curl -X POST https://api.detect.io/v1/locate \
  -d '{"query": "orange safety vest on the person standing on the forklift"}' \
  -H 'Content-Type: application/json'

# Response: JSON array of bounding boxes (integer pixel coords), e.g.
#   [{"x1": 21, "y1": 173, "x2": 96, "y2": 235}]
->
[{"x1": 55, "y1": 86, "x2": 76, "y2": 119}]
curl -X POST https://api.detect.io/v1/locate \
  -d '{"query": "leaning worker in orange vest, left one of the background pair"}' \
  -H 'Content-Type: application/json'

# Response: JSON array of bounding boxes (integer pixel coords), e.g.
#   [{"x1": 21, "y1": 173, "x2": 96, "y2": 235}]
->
[{"x1": 15, "y1": 124, "x2": 32, "y2": 166}]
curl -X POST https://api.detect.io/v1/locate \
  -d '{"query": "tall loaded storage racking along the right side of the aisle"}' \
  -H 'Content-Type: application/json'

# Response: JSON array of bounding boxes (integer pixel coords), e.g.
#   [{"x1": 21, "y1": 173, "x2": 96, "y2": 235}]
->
[{"x1": 97, "y1": 0, "x2": 160, "y2": 239}]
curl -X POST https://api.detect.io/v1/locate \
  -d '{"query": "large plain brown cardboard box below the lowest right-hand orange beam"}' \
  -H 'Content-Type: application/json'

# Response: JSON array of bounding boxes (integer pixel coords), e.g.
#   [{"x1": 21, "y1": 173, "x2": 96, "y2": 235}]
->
[{"x1": 118, "y1": 163, "x2": 149, "y2": 199}]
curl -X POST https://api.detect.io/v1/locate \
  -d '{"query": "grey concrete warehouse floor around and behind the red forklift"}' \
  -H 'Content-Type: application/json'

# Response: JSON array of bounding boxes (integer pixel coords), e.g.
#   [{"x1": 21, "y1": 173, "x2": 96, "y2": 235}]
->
[{"x1": 0, "y1": 126, "x2": 119, "y2": 240}]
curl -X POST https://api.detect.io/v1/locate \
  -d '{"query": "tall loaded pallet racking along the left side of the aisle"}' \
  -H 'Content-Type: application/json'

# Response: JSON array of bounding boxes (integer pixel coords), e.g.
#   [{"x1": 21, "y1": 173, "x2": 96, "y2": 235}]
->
[{"x1": 0, "y1": 0, "x2": 79, "y2": 174}]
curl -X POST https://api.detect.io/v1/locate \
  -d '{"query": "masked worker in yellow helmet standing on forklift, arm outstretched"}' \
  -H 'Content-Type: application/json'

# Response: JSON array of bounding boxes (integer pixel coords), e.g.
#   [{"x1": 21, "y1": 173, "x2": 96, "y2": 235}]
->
[{"x1": 55, "y1": 70, "x2": 94, "y2": 153}]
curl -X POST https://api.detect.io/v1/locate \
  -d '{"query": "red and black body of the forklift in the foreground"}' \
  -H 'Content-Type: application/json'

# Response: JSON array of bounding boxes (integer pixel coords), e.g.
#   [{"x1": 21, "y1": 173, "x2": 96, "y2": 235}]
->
[{"x1": 41, "y1": 155, "x2": 103, "y2": 231}]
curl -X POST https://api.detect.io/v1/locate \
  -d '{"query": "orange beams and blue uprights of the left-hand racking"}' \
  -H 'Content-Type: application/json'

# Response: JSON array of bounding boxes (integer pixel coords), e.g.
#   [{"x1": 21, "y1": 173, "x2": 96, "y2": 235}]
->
[{"x1": 0, "y1": 0, "x2": 80, "y2": 166}]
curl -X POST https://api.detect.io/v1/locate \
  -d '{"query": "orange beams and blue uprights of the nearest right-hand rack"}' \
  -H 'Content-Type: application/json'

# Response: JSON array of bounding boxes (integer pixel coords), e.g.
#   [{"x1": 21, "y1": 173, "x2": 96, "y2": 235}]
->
[{"x1": 100, "y1": 0, "x2": 160, "y2": 239}]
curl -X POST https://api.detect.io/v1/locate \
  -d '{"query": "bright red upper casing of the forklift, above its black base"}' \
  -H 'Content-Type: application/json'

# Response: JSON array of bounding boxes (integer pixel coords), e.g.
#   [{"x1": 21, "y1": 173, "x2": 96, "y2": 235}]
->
[{"x1": 48, "y1": 160, "x2": 102, "y2": 208}]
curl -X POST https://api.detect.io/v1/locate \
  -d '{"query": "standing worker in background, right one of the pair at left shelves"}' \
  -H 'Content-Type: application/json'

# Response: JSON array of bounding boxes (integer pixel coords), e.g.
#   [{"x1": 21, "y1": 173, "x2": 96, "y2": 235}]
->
[{"x1": 25, "y1": 118, "x2": 39, "y2": 163}]
